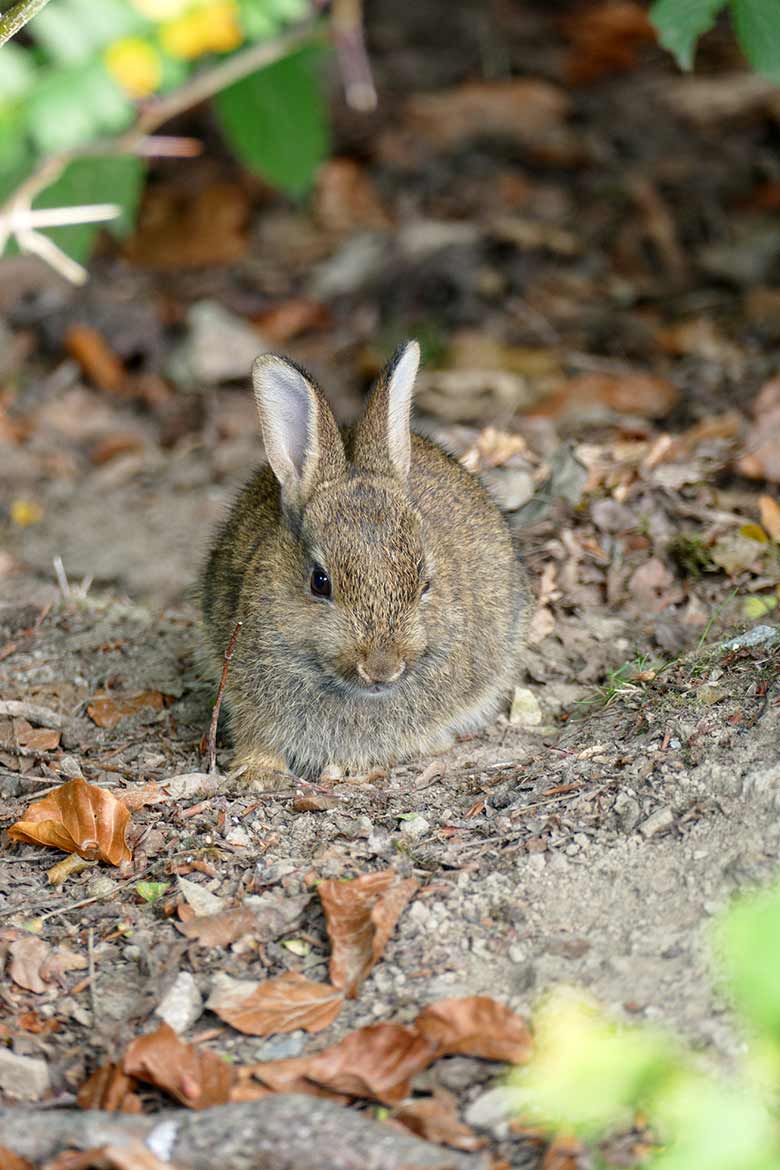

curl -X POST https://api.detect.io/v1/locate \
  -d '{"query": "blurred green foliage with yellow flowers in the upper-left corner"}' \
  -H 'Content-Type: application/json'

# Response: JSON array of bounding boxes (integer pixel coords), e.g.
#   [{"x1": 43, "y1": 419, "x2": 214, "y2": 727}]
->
[{"x1": 0, "y1": 0, "x2": 329, "y2": 262}]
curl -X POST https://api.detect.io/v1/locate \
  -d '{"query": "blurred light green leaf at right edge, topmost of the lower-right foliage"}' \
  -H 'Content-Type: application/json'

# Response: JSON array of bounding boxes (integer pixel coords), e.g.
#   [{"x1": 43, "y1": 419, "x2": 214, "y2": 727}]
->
[{"x1": 716, "y1": 889, "x2": 780, "y2": 1042}]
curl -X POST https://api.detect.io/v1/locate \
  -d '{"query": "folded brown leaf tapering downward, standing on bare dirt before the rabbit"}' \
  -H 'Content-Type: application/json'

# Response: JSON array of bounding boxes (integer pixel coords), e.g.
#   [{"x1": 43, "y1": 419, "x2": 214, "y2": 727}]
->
[{"x1": 317, "y1": 869, "x2": 417, "y2": 999}]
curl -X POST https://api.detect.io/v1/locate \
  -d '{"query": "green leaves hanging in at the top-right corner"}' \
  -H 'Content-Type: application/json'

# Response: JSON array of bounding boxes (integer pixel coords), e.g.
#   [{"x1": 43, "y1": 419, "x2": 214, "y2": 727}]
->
[{"x1": 650, "y1": 0, "x2": 780, "y2": 81}]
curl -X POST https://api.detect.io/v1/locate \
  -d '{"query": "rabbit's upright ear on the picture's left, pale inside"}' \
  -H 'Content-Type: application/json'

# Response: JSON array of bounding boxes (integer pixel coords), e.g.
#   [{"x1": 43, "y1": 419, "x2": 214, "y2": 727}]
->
[{"x1": 251, "y1": 353, "x2": 346, "y2": 508}]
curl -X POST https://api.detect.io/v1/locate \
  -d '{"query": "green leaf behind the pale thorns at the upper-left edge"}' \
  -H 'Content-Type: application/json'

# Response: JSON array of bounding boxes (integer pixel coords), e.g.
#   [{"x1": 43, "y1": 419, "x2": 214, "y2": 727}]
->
[{"x1": 34, "y1": 156, "x2": 144, "y2": 263}]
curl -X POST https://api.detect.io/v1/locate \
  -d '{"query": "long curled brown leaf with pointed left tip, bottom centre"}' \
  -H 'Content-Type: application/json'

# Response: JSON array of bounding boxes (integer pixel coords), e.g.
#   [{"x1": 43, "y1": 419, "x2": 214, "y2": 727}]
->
[{"x1": 251, "y1": 1024, "x2": 436, "y2": 1104}]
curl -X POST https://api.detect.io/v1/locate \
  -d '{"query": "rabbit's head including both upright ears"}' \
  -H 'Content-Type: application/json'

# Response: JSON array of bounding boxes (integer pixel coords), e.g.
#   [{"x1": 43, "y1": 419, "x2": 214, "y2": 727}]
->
[{"x1": 253, "y1": 342, "x2": 436, "y2": 700}]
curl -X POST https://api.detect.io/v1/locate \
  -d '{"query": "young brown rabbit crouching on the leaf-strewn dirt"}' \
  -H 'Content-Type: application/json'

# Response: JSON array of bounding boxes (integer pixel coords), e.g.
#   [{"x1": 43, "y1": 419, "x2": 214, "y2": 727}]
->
[{"x1": 202, "y1": 342, "x2": 529, "y2": 785}]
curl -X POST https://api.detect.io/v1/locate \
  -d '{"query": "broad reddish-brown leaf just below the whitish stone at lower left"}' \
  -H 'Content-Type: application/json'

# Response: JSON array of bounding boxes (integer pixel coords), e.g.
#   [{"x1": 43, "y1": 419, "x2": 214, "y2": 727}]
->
[{"x1": 122, "y1": 1024, "x2": 235, "y2": 1109}]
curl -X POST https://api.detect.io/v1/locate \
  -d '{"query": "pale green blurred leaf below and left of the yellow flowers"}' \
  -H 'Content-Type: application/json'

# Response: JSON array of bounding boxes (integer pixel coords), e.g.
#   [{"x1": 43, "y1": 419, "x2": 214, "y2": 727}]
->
[{"x1": 27, "y1": 61, "x2": 134, "y2": 154}]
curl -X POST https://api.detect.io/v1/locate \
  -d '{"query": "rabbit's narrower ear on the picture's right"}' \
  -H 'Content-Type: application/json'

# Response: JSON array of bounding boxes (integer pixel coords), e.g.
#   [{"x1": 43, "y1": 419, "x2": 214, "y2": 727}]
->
[{"x1": 353, "y1": 342, "x2": 420, "y2": 480}]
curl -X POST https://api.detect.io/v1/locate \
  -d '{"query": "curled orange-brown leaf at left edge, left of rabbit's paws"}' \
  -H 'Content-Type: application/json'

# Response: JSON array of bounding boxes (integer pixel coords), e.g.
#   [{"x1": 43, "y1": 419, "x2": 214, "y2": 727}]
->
[{"x1": 8, "y1": 778, "x2": 130, "y2": 866}]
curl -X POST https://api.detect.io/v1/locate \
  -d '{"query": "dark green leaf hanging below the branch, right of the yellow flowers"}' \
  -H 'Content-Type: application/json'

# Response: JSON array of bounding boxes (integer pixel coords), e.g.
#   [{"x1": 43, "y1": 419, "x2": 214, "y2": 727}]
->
[{"x1": 214, "y1": 48, "x2": 329, "y2": 195}]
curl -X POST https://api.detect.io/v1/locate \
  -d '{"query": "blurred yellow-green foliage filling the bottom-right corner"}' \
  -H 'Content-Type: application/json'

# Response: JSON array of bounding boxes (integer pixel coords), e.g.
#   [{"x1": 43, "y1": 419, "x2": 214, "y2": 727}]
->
[{"x1": 511, "y1": 888, "x2": 780, "y2": 1170}]
